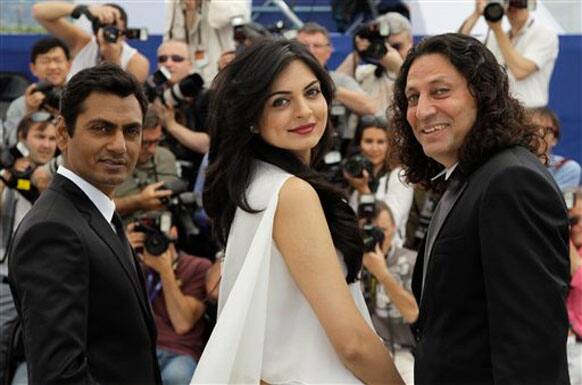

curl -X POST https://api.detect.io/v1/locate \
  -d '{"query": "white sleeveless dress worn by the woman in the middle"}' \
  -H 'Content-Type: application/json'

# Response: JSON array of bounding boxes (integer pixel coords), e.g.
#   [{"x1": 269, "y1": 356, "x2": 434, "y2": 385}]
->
[{"x1": 191, "y1": 161, "x2": 372, "y2": 384}]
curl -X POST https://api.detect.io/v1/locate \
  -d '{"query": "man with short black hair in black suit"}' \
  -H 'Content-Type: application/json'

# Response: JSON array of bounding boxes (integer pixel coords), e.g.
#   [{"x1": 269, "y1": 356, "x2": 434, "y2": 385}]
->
[{"x1": 9, "y1": 64, "x2": 161, "y2": 385}]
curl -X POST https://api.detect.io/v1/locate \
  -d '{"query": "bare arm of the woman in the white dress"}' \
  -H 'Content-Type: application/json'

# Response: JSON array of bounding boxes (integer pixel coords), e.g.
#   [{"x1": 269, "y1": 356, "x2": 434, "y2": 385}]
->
[{"x1": 273, "y1": 178, "x2": 403, "y2": 384}]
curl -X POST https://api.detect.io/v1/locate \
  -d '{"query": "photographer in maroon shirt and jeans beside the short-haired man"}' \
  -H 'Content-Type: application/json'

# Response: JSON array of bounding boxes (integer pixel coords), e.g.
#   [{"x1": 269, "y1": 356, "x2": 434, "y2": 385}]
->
[{"x1": 127, "y1": 221, "x2": 211, "y2": 385}]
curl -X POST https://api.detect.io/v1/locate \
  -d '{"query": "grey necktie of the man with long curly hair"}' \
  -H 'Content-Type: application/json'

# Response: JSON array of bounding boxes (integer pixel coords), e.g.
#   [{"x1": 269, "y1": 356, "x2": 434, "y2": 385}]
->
[{"x1": 421, "y1": 170, "x2": 463, "y2": 298}]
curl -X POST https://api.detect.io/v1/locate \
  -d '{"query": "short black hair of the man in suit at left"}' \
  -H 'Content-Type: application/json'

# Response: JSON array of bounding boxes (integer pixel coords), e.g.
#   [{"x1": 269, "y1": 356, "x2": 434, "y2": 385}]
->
[{"x1": 61, "y1": 63, "x2": 148, "y2": 136}]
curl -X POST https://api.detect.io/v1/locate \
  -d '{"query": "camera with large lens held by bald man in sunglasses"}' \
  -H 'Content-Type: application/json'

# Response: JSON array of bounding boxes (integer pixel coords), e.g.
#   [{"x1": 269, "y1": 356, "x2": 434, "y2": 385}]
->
[{"x1": 144, "y1": 66, "x2": 204, "y2": 107}]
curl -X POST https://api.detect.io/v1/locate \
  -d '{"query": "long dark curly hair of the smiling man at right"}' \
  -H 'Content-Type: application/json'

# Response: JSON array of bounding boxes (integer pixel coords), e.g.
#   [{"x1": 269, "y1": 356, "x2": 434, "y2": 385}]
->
[{"x1": 390, "y1": 33, "x2": 543, "y2": 190}]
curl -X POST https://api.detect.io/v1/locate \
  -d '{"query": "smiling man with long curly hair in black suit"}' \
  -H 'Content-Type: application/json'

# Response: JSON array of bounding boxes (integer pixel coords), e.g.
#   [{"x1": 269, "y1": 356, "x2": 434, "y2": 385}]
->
[{"x1": 393, "y1": 34, "x2": 569, "y2": 385}]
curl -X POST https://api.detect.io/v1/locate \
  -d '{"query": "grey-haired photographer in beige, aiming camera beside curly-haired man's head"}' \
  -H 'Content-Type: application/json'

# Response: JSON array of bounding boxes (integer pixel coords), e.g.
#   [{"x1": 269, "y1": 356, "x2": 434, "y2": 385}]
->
[{"x1": 337, "y1": 12, "x2": 413, "y2": 116}]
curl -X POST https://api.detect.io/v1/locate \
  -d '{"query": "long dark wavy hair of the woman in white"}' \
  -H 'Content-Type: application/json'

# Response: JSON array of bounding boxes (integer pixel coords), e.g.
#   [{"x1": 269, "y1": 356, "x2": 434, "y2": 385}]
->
[{"x1": 204, "y1": 40, "x2": 363, "y2": 283}]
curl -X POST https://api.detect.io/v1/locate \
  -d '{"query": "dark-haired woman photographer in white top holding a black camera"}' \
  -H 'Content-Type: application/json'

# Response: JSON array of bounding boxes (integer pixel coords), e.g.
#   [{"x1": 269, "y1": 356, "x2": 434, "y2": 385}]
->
[{"x1": 343, "y1": 115, "x2": 413, "y2": 246}]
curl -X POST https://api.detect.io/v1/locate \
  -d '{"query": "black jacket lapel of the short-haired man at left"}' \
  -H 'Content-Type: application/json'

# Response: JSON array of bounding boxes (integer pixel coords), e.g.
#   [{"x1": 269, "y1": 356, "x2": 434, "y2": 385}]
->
[{"x1": 50, "y1": 174, "x2": 153, "y2": 333}]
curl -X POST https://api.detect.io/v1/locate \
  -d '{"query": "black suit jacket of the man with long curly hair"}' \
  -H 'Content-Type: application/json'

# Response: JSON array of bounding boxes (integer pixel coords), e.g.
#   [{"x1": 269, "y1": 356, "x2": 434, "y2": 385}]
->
[{"x1": 413, "y1": 147, "x2": 569, "y2": 385}]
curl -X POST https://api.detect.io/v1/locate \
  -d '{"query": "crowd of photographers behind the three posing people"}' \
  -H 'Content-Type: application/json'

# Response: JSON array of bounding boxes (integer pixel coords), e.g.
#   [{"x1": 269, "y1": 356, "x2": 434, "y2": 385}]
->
[{"x1": 0, "y1": 0, "x2": 582, "y2": 384}]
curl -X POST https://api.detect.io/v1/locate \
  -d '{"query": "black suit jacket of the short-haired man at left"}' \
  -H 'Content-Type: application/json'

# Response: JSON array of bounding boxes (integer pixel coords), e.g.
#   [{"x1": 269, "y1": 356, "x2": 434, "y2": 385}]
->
[{"x1": 9, "y1": 174, "x2": 161, "y2": 385}]
